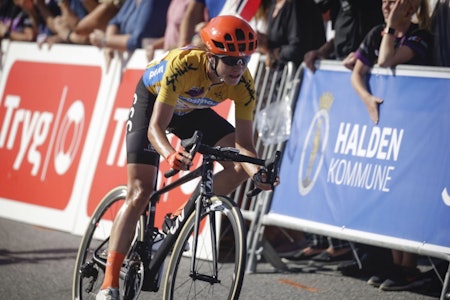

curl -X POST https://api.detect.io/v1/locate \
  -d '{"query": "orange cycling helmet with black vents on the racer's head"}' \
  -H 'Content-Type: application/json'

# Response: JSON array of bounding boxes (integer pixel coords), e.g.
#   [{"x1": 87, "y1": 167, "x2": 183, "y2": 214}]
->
[{"x1": 200, "y1": 16, "x2": 258, "y2": 56}]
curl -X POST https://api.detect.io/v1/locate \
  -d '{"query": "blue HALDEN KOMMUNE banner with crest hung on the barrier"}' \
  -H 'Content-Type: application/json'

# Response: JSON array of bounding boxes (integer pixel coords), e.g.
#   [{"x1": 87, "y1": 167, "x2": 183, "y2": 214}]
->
[{"x1": 271, "y1": 65, "x2": 450, "y2": 247}]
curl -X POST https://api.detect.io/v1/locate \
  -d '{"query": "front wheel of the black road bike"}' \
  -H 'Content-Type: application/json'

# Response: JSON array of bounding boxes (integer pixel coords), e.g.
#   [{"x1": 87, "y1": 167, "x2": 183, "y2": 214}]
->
[{"x1": 164, "y1": 196, "x2": 247, "y2": 300}]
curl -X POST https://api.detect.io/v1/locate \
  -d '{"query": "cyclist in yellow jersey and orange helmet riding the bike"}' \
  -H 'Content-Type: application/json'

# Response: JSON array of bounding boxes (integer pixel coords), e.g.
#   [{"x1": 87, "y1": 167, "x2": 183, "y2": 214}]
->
[{"x1": 96, "y1": 16, "x2": 272, "y2": 300}]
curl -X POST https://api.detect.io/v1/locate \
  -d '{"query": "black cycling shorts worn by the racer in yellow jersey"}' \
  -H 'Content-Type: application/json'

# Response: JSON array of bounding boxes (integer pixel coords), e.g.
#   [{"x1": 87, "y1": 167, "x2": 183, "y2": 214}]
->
[{"x1": 126, "y1": 79, "x2": 234, "y2": 166}]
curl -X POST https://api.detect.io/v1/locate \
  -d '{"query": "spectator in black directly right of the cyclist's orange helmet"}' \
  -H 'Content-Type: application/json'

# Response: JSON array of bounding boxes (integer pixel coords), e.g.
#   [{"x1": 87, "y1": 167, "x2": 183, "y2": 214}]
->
[{"x1": 260, "y1": 0, "x2": 326, "y2": 67}]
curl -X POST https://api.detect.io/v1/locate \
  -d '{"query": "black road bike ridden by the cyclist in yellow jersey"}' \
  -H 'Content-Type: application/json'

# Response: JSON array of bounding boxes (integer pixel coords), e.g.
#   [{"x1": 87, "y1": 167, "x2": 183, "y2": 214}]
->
[{"x1": 72, "y1": 131, "x2": 281, "y2": 300}]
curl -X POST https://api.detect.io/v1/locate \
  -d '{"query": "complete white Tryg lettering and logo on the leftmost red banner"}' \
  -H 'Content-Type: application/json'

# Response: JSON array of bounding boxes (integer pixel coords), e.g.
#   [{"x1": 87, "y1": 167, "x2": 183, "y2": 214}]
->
[{"x1": 0, "y1": 87, "x2": 85, "y2": 180}]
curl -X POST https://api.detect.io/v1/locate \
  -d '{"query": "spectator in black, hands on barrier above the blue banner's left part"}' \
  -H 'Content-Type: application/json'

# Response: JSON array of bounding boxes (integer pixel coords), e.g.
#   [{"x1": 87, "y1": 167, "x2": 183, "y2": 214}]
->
[{"x1": 304, "y1": 0, "x2": 383, "y2": 71}]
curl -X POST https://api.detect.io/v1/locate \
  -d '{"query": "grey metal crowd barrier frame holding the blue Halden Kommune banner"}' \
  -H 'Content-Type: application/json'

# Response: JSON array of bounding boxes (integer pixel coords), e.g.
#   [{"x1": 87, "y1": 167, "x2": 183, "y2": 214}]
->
[{"x1": 234, "y1": 57, "x2": 450, "y2": 299}]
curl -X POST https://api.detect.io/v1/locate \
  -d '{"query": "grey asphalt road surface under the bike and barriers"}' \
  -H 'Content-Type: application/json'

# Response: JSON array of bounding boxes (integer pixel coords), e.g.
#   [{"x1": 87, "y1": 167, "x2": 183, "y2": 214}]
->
[{"x1": 0, "y1": 218, "x2": 440, "y2": 300}]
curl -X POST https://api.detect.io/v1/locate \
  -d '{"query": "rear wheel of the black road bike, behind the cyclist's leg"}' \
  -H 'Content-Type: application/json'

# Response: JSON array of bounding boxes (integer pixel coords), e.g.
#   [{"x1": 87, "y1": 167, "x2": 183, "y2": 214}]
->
[{"x1": 72, "y1": 186, "x2": 145, "y2": 300}]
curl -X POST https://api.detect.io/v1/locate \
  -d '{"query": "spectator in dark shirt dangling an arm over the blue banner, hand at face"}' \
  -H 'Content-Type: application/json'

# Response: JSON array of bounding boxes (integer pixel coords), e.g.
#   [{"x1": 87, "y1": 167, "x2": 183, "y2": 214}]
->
[{"x1": 351, "y1": 0, "x2": 432, "y2": 124}]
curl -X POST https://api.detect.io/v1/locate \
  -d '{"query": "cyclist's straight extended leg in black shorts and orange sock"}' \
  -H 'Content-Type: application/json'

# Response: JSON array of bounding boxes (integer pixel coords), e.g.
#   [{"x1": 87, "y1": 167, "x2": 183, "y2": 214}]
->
[{"x1": 102, "y1": 80, "x2": 159, "y2": 289}]
